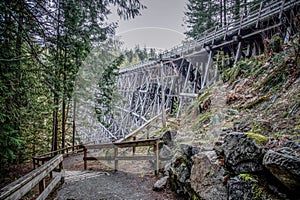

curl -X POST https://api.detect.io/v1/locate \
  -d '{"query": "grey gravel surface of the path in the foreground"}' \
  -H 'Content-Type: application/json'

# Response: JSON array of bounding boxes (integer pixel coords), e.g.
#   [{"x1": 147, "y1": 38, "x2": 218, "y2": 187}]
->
[{"x1": 57, "y1": 172, "x2": 176, "y2": 200}]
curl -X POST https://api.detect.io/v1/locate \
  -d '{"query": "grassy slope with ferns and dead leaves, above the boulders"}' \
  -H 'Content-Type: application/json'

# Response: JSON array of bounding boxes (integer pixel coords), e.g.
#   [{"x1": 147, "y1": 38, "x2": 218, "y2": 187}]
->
[{"x1": 179, "y1": 36, "x2": 300, "y2": 143}]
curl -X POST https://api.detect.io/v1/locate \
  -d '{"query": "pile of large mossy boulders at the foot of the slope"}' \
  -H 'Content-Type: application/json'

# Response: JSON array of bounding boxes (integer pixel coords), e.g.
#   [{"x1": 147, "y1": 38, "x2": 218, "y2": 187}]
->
[{"x1": 165, "y1": 132, "x2": 300, "y2": 200}]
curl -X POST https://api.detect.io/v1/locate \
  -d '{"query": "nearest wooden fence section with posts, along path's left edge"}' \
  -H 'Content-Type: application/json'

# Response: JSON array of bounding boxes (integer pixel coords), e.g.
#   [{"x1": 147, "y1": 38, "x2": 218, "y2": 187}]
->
[{"x1": 0, "y1": 155, "x2": 64, "y2": 200}]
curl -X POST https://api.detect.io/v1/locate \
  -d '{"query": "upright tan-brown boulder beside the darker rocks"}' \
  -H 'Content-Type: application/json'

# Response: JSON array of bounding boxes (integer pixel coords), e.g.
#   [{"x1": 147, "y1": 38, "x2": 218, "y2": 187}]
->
[{"x1": 190, "y1": 151, "x2": 228, "y2": 200}]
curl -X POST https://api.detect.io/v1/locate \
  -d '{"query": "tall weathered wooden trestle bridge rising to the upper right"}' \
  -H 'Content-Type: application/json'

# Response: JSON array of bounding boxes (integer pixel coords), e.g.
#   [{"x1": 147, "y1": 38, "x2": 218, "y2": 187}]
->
[{"x1": 90, "y1": 0, "x2": 299, "y2": 141}]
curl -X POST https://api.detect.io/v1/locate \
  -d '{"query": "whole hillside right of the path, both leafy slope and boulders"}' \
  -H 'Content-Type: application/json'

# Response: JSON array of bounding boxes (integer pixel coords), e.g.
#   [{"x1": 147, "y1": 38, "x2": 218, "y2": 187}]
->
[{"x1": 164, "y1": 35, "x2": 300, "y2": 199}]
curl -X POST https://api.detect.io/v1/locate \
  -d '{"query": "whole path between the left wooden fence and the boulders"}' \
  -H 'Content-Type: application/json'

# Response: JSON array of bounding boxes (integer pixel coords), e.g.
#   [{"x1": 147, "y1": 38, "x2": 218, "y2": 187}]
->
[{"x1": 54, "y1": 152, "x2": 182, "y2": 200}]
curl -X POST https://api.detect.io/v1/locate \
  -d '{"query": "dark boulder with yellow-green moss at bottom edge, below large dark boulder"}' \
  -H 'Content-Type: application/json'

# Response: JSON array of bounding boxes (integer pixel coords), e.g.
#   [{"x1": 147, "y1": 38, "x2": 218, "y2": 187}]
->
[{"x1": 228, "y1": 174, "x2": 279, "y2": 200}]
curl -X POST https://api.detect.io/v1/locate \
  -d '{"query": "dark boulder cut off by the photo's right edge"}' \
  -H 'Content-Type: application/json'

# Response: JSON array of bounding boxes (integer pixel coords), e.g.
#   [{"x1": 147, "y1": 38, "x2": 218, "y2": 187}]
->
[{"x1": 263, "y1": 142, "x2": 300, "y2": 192}]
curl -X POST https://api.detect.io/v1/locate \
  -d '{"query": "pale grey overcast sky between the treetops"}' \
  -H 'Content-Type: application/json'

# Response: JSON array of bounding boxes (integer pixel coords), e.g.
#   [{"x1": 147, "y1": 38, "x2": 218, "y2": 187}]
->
[{"x1": 110, "y1": 0, "x2": 187, "y2": 50}]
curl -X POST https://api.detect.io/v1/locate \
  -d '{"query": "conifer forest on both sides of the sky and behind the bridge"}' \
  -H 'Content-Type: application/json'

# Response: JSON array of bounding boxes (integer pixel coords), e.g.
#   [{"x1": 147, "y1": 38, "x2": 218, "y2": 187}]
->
[{"x1": 0, "y1": 0, "x2": 282, "y2": 169}]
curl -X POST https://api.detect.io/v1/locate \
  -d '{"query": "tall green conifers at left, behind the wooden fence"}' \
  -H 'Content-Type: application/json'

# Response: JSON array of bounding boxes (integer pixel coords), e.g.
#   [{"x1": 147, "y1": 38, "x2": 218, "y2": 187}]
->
[{"x1": 0, "y1": 0, "x2": 144, "y2": 168}]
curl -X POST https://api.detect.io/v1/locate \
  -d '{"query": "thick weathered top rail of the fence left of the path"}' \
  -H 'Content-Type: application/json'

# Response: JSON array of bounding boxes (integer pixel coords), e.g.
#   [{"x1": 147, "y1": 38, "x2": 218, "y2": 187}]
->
[{"x1": 0, "y1": 155, "x2": 63, "y2": 200}]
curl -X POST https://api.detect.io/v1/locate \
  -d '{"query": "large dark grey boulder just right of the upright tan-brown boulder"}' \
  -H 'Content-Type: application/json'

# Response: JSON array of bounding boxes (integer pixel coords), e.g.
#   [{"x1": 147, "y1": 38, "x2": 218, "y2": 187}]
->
[{"x1": 222, "y1": 132, "x2": 265, "y2": 174}]
